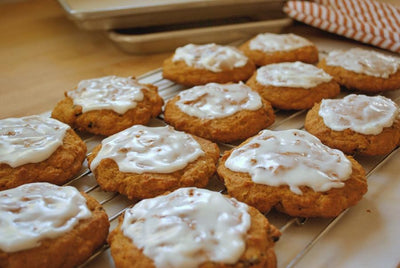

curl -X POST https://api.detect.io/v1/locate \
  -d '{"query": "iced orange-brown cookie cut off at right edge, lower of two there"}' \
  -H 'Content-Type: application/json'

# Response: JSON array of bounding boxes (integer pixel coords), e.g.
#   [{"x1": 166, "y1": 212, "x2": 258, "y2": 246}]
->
[{"x1": 305, "y1": 94, "x2": 400, "y2": 155}]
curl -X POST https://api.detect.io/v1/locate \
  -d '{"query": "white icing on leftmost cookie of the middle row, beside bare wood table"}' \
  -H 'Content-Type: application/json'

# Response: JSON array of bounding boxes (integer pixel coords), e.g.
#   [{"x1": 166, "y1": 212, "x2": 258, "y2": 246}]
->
[{"x1": 67, "y1": 76, "x2": 147, "y2": 114}]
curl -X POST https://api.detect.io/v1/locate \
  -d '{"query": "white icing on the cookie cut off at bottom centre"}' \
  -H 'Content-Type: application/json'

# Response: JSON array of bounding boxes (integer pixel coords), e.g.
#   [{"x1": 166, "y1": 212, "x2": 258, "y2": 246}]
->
[{"x1": 122, "y1": 188, "x2": 250, "y2": 268}]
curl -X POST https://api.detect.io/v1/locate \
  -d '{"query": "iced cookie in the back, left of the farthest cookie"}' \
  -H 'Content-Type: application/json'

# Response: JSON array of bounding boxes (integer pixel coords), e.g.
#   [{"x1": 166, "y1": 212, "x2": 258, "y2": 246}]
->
[{"x1": 163, "y1": 44, "x2": 255, "y2": 86}]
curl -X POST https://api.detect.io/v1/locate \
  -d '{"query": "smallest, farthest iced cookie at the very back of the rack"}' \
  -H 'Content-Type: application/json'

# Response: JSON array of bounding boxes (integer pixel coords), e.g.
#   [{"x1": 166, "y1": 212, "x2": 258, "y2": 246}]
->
[{"x1": 240, "y1": 33, "x2": 318, "y2": 66}]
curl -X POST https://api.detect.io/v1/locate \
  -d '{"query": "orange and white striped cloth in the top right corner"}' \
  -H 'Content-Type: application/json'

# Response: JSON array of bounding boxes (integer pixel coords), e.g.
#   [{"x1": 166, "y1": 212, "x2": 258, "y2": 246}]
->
[{"x1": 283, "y1": 0, "x2": 400, "y2": 53}]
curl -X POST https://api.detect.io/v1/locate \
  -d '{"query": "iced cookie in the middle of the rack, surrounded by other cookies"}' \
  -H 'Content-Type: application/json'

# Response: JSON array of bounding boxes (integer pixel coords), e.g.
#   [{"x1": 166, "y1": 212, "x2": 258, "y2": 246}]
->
[{"x1": 164, "y1": 83, "x2": 275, "y2": 142}]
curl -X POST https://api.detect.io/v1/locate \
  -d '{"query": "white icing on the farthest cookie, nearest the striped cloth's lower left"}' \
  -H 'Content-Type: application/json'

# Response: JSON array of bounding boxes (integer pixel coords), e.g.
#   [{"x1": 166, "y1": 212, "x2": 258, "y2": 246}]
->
[{"x1": 249, "y1": 33, "x2": 313, "y2": 52}]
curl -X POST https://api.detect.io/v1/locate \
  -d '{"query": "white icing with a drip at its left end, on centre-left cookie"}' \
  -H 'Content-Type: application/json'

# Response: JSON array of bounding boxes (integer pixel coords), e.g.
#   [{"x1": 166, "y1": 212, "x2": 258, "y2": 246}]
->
[{"x1": 90, "y1": 125, "x2": 204, "y2": 174}]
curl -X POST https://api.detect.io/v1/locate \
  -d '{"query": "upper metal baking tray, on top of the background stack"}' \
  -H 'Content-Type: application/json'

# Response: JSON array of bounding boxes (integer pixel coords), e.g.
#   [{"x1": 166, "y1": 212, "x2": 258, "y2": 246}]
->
[{"x1": 58, "y1": 0, "x2": 285, "y2": 30}]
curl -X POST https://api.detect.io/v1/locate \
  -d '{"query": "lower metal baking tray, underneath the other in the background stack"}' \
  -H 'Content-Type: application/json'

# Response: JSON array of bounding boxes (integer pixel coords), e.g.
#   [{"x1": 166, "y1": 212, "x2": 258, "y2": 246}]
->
[{"x1": 106, "y1": 18, "x2": 292, "y2": 54}]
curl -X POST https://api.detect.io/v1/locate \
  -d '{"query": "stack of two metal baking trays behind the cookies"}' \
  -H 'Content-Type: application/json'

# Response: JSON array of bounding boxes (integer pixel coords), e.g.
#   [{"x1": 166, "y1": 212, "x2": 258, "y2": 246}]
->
[{"x1": 59, "y1": 0, "x2": 291, "y2": 53}]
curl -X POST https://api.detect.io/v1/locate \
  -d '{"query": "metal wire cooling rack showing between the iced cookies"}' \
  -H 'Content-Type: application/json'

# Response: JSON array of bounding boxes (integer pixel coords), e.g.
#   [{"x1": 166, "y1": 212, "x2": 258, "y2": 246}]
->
[{"x1": 66, "y1": 68, "x2": 400, "y2": 268}]
